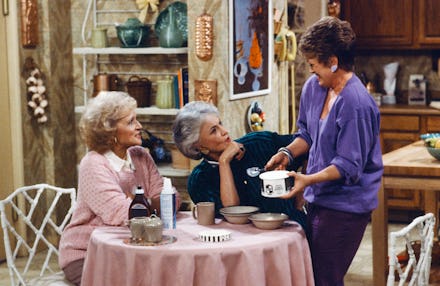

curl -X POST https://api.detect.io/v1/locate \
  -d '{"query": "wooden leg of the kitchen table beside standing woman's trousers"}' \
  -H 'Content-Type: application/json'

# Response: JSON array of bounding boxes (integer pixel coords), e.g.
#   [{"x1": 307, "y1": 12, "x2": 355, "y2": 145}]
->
[{"x1": 371, "y1": 178, "x2": 388, "y2": 285}]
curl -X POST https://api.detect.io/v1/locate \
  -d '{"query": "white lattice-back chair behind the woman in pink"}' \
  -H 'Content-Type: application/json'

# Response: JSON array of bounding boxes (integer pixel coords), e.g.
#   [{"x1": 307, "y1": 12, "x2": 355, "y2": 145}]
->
[{"x1": 0, "y1": 184, "x2": 76, "y2": 285}]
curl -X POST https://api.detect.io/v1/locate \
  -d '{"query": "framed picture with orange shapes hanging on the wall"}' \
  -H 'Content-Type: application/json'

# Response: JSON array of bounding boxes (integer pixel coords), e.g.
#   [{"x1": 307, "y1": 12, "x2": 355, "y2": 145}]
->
[{"x1": 229, "y1": 0, "x2": 273, "y2": 100}]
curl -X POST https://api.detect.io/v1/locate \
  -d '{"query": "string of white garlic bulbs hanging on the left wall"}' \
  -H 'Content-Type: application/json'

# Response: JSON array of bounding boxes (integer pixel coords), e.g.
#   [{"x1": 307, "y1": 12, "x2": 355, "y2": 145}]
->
[{"x1": 24, "y1": 58, "x2": 49, "y2": 124}]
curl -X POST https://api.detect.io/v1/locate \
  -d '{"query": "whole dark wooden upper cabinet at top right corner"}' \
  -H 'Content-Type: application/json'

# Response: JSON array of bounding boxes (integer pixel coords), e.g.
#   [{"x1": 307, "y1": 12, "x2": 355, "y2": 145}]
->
[{"x1": 341, "y1": 0, "x2": 440, "y2": 50}]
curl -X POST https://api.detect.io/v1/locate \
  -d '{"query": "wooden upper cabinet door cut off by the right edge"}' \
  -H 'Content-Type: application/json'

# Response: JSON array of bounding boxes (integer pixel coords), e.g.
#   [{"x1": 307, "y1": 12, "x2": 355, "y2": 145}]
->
[{"x1": 415, "y1": 0, "x2": 440, "y2": 46}]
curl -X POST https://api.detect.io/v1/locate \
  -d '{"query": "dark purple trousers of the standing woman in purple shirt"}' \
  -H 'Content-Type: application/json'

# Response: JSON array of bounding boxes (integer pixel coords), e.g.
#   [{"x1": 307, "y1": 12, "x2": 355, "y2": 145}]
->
[{"x1": 306, "y1": 204, "x2": 371, "y2": 286}]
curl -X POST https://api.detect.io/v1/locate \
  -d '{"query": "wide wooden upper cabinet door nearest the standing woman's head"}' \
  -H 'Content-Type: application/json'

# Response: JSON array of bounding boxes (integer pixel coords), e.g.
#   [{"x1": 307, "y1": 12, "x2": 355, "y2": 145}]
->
[{"x1": 342, "y1": 0, "x2": 412, "y2": 49}]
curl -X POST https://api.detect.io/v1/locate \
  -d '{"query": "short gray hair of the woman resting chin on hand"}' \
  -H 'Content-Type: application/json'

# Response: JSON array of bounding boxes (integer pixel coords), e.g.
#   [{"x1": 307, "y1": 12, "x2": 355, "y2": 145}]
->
[{"x1": 173, "y1": 101, "x2": 219, "y2": 160}]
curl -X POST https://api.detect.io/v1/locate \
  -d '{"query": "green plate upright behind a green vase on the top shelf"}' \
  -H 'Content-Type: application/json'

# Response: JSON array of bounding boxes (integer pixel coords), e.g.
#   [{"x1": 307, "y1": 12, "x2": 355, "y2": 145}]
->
[{"x1": 154, "y1": 1, "x2": 188, "y2": 44}]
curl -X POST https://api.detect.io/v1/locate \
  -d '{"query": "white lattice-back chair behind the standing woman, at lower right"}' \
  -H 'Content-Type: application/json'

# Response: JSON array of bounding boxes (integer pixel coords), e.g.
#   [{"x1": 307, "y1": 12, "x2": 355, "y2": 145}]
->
[{"x1": 387, "y1": 213, "x2": 435, "y2": 286}]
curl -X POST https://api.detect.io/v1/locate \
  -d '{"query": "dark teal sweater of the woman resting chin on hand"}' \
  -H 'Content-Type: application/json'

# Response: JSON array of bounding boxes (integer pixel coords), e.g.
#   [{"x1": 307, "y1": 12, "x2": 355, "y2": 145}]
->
[{"x1": 188, "y1": 131, "x2": 305, "y2": 227}]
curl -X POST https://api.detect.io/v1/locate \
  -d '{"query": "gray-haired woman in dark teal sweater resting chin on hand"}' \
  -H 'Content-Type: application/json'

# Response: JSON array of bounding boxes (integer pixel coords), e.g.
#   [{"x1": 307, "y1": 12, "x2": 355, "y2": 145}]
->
[{"x1": 173, "y1": 101, "x2": 305, "y2": 225}]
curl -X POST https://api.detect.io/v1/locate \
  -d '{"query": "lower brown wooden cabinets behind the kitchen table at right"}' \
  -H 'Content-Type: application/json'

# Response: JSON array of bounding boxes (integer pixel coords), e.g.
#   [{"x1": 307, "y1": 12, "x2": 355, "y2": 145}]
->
[{"x1": 380, "y1": 105, "x2": 440, "y2": 210}]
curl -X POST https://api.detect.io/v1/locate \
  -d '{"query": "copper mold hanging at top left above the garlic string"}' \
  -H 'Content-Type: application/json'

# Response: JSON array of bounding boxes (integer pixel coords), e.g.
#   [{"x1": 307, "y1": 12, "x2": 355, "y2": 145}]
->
[{"x1": 21, "y1": 0, "x2": 38, "y2": 48}]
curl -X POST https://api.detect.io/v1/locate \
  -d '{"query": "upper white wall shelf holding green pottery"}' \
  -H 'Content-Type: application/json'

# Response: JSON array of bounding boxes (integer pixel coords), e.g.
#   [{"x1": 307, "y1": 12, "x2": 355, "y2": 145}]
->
[{"x1": 73, "y1": 47, "x2": 188, "y2": 55}]
